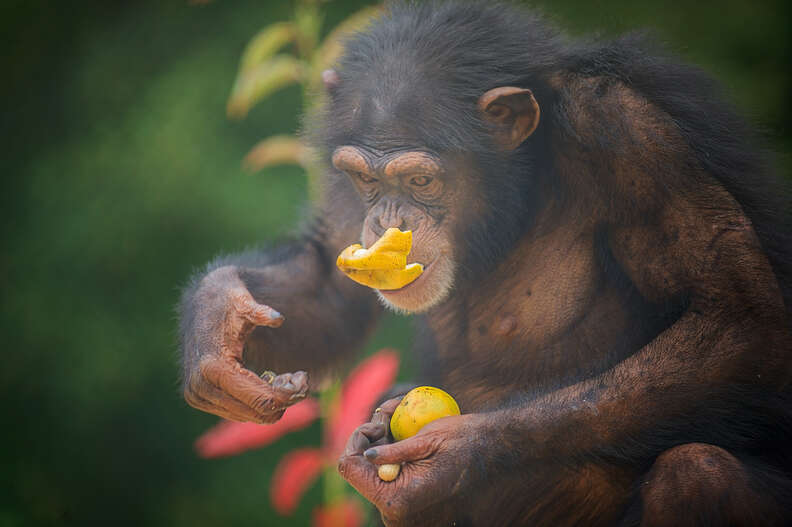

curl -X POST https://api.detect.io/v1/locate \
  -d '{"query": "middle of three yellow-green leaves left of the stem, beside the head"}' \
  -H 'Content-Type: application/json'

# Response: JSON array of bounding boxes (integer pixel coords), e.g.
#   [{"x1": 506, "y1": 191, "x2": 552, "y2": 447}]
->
[{"x1": 226, "y1": 55, "x2": 304, "y2": 119}]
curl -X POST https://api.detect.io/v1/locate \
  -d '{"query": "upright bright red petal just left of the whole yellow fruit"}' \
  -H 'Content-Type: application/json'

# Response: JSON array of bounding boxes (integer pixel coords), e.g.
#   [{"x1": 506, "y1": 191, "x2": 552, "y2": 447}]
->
[{"x1": 325, "y1": 349, "x2": 399, "y2": 456}]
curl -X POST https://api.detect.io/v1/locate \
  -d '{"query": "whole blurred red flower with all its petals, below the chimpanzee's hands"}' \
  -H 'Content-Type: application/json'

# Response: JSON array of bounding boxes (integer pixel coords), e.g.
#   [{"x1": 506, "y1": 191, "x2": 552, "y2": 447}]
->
[{"x1": 195, "y1": 350, "x2": 399, "y2": 527}]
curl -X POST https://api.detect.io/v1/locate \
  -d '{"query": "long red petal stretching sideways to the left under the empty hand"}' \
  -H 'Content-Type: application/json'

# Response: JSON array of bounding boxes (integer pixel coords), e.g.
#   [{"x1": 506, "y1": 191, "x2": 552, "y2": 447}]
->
[{"x1": 195, "y1": 399, "x2": 319, "y2": 458}]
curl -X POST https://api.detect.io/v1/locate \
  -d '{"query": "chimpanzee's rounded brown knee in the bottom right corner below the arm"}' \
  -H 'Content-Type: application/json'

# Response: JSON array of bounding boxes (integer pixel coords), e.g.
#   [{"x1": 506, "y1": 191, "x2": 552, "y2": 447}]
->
[{"x1": 640, "y1": 443, "x2": 783, "y2": 527}]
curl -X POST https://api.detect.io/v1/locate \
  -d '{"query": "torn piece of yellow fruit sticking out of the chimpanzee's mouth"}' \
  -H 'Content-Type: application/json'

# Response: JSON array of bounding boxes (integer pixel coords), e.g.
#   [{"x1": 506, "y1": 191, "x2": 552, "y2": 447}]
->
[{"x1": 336, "y1": 228, "x2": 423, "y2": 290}]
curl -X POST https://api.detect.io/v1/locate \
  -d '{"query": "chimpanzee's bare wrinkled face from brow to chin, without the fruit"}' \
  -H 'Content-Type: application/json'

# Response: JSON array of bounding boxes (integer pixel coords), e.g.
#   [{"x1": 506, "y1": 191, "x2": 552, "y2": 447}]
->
[{"x1": 332, "y1": 146, "x2": 465, "y2": 312}]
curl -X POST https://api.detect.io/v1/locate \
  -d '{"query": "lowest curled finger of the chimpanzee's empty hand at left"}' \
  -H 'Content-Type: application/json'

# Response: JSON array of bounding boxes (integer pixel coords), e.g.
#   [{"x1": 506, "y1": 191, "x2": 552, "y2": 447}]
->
[{"x1": 200, "y1": 357, "x2": 307, "y2": 420}]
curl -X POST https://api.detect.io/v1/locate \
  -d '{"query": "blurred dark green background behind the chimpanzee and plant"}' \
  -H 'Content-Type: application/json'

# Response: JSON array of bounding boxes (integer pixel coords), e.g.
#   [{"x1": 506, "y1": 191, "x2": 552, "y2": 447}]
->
[{"x1": 0, "y1": 0, "x2": 792, "y2": 527}]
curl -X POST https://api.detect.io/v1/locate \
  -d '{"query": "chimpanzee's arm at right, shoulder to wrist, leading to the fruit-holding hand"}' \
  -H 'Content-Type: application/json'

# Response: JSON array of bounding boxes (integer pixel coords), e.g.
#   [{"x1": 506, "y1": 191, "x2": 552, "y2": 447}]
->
[{"x1": 486, "y1": 78, "x2": 792, "y2": 466}]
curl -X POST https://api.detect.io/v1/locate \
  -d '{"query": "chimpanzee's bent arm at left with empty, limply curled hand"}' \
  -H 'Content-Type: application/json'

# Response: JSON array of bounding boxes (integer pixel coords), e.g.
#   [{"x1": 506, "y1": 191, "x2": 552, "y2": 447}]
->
[{"x1": 180, "y1": 179, "x2": 381, "y2": 422}]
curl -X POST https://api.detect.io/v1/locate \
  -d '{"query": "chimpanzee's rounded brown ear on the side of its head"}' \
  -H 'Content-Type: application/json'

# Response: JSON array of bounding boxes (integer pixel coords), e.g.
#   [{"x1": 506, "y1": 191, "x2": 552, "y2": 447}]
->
[{"x1": 478, "y1": 86, "x2": 539, "y2": 150}]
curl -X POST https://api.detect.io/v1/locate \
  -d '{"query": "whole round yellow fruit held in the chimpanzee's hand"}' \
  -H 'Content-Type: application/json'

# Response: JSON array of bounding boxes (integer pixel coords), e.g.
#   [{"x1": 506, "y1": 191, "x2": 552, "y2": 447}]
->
[{"x1": 390, "y1": 386, "x2": 460, "y2": 441}]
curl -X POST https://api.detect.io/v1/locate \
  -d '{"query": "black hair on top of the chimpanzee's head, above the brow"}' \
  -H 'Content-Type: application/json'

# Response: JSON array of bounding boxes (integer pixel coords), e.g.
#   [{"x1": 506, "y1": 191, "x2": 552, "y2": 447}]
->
[{"x1": 314, "y1": 2, "x2": 561, "y2": 156}]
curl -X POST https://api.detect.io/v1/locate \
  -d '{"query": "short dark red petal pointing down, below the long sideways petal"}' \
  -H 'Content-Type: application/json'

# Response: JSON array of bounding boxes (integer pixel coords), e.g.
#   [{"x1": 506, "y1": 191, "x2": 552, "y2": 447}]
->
[{"x1": 270, "y1": 448, "x2": 322, "y2": 515}]
